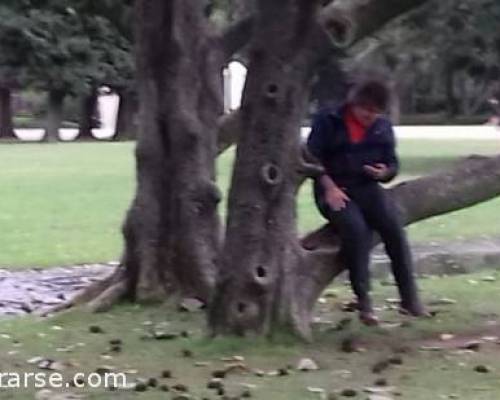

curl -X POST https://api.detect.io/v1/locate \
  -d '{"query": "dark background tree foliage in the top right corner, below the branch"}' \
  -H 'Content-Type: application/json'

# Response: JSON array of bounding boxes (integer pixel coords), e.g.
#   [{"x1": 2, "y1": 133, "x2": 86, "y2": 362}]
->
[{"x1": 355, "y1": 0, "x2": 500, "y2": 118}]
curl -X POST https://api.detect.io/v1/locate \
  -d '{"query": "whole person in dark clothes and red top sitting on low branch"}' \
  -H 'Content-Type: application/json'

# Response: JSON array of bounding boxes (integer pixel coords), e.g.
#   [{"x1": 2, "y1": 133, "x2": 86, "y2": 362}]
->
[{"x1": 307, "y1": 80, "x2": 426, "y2": 325}]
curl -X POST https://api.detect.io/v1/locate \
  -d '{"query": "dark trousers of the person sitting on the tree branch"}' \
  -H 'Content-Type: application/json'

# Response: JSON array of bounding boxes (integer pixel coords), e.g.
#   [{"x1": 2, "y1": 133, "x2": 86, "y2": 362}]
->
[{"x1": 317, "y1": 182, "x2": 419, "y2": 311}]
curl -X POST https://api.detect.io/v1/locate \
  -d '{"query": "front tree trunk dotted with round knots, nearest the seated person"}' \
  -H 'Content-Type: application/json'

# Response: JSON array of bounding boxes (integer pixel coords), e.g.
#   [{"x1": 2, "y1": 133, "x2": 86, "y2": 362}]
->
[{"x1": 209, "y1": 0, "x2": 318, "y2": 334}]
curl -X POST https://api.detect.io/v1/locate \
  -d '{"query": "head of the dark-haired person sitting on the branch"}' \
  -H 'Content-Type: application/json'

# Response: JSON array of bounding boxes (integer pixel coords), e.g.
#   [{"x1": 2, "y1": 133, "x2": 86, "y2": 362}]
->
[{"x1": 349, "y1": 80, "x2": 391, "y2": 127}]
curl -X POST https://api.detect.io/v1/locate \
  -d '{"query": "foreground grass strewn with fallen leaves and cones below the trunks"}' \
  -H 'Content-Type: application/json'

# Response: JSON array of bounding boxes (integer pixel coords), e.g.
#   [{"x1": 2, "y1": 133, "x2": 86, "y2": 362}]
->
[{"x1": 0, "y1": 274, "x2": 500, "y2": 400}]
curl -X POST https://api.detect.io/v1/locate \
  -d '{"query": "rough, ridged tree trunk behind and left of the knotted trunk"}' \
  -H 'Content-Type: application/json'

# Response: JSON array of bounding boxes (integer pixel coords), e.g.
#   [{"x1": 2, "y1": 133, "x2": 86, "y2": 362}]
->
[{"x1": 118, "y1": 0, "x2": 223, "y2": 300}]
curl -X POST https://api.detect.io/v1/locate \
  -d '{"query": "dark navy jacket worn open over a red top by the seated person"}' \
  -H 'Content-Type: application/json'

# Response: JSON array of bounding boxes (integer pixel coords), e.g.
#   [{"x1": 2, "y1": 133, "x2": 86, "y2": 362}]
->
[{"x1": 307, "y1": 106, "x2": 399, "y2": 187}]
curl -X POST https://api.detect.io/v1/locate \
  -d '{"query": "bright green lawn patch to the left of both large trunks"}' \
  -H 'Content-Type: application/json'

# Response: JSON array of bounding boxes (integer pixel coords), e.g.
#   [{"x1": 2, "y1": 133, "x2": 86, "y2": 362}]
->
[{"x1": 0, "y1": 143, "x2": 134, "y2": 266}]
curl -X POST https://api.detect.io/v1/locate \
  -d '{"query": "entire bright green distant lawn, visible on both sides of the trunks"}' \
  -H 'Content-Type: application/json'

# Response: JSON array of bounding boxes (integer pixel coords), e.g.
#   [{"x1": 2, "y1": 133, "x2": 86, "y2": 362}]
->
[{"x1": 0, "y1": 140, "x2": 500, "y2": 267}]
